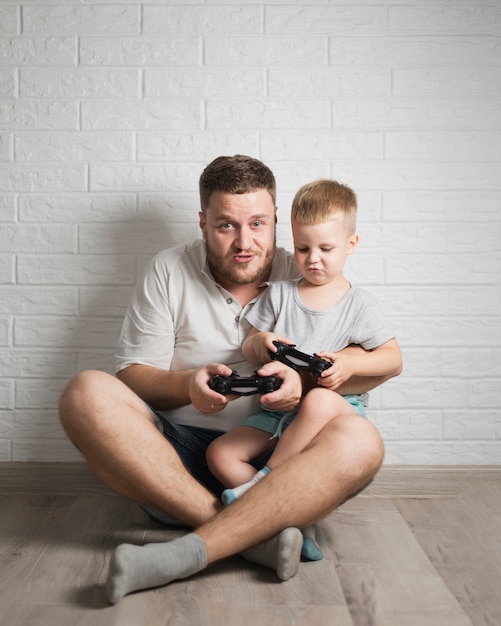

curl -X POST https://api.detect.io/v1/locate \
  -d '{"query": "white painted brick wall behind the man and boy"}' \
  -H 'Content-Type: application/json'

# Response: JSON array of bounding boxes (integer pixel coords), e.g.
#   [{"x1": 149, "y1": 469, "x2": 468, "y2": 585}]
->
[{"x1": 0, "y1": 0, "x2": 501, "y2": 464}]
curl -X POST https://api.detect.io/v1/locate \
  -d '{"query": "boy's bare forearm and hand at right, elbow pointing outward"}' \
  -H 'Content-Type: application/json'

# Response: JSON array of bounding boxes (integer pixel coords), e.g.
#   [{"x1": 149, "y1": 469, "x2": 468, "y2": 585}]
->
[{"x1": 318, "y1": 339, "x2": 402, "y2": 393}]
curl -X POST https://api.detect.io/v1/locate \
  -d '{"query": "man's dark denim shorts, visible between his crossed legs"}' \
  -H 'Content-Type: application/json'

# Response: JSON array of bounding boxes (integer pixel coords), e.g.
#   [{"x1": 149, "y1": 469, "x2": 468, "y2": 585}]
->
[{"x1": 139, "y1": 407, "x2": 271, "y2": 526}]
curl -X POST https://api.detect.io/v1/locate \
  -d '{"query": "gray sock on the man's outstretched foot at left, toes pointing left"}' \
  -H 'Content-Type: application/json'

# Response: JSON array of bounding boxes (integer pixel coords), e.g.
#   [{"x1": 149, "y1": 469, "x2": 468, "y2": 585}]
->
[{"x1": 106, "y1": 533, "x2": 207, "y2": 604}]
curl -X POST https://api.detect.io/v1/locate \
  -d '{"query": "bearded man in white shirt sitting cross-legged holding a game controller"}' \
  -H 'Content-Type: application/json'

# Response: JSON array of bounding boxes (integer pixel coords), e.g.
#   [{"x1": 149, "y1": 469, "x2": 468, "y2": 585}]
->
[{"x1": 60, "y1": 155, "x2": 397, "y2": 602}]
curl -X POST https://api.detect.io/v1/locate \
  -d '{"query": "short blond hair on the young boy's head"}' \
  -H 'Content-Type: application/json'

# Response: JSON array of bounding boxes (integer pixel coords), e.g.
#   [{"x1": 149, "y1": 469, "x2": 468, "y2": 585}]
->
[{"x1": 291, "y1": 179, "x2": 357, "y2": 234}]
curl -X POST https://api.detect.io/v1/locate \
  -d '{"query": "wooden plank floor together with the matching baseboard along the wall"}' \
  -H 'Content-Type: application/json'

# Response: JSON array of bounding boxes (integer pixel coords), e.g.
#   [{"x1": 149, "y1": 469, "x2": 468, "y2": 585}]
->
[{"x1": 0, "y1": 463, "x2": 501, "y2": 626}]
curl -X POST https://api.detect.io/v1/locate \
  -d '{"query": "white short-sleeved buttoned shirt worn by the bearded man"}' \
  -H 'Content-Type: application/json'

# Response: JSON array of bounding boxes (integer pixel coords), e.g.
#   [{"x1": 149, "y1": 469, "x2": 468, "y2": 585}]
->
[{"x1": 115, "y1": 239, "x2": 298, "y2": 430}]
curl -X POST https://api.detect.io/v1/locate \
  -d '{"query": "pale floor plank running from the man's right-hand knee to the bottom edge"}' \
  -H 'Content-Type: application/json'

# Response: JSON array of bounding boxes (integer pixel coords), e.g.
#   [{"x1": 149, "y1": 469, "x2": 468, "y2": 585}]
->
[{"x1": 323, "y1": 499, "x2": 471, "y2": 626}]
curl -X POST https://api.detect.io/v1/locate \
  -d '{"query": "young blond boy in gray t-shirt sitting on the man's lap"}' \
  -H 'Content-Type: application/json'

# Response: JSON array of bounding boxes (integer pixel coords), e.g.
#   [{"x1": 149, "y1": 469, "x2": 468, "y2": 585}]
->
[{"x1": 207, "y1": 180, "x2": 402, "y2": 560}]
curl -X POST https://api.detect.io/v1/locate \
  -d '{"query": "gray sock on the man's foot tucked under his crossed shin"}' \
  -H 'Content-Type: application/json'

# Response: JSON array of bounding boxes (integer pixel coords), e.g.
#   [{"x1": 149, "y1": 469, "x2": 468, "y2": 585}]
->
[{"x1": 240, "y1": 528, "x2": 303, "y2": 580}]
